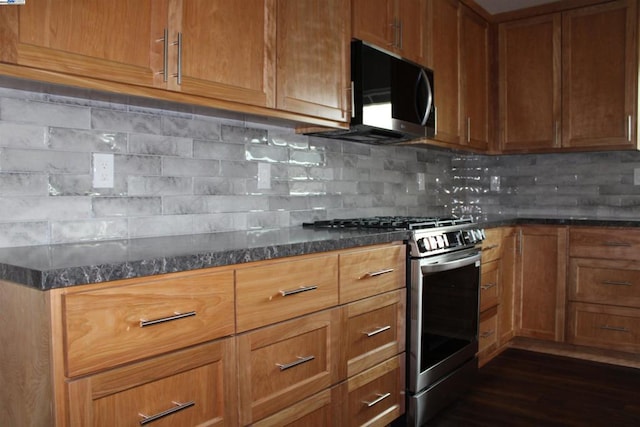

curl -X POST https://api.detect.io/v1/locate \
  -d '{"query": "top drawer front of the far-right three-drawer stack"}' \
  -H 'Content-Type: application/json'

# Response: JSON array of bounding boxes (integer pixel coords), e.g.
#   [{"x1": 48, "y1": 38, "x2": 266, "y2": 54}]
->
[{"x1": 569, "y1": 227, "x2": 640, "y2": 260}]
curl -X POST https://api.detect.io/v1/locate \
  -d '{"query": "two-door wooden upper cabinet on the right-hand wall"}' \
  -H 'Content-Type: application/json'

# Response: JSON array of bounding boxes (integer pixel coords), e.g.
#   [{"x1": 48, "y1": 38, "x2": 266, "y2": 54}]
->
[{"x1": 499, "y1": 0, "x2": 638, "y2": 152}]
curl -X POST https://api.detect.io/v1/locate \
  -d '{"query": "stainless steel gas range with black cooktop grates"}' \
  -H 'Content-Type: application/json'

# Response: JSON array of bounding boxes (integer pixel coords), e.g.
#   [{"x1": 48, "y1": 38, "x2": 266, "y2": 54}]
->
[{"x1": 307, "y1": 217, "x2": 485, "y2": 426}]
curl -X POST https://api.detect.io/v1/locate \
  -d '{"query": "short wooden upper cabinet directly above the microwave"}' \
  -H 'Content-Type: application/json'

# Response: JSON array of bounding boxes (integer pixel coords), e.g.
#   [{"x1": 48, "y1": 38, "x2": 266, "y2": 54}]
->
[{"x1": 352, "y1": 0, "x2": 428, "y2": 64}]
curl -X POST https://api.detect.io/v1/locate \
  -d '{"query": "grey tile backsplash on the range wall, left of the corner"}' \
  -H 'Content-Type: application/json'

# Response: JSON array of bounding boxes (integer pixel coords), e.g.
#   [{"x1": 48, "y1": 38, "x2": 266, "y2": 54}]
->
[{"x1": 0, "y1": 83, "x2": 454, "y2": 247}]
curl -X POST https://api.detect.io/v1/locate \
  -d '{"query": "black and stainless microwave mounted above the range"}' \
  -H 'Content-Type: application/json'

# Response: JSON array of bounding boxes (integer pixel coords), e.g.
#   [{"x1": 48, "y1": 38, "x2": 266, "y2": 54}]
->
[{"x1": 307, "y1": 40, "x2": 435, "y2": 144}]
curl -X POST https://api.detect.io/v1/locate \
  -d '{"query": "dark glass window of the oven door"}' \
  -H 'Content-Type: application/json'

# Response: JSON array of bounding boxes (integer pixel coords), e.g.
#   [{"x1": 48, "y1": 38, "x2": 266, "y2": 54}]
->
[{"x1": 420, "y1": 264, "x2": 480, "y2": 372}]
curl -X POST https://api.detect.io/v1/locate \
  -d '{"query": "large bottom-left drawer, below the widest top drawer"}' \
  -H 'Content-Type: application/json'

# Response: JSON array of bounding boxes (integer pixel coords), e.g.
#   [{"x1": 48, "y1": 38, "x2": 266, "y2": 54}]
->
[{"x1": 67, "y1": 338, "x2": 237, "y2": 427}]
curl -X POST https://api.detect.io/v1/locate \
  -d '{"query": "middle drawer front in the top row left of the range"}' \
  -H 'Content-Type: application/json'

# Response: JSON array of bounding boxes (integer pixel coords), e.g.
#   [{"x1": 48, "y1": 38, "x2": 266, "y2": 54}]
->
[{"x1": 236, "y1": 255, "x2": 338, "y2": 332}]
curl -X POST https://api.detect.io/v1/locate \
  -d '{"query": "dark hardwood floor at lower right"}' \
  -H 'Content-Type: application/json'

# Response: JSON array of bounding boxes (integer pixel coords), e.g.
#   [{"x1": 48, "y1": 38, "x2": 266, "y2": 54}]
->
[{"x1": 427, "y1": 349, "x2": 640, "y2": 427}]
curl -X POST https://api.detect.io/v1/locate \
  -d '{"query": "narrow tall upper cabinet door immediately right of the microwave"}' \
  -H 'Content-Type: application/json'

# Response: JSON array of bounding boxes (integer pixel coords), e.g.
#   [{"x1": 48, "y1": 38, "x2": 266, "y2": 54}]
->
[{"x1": 428, "y1": 0, "x2": 460, "y2": 144}]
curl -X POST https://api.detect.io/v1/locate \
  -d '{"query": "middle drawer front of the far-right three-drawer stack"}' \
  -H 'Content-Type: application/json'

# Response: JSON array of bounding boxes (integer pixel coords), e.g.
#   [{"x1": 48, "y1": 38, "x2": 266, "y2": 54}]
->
[{"x1": 569, "y1": 258, "x2": 640, "y2": 308}]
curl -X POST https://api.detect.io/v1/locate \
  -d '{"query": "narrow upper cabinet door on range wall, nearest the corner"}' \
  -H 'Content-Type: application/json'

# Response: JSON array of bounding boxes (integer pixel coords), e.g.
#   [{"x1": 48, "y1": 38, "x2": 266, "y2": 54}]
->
[{"x1": 460, "y1": 6, "x2": 489, "y2": 150}]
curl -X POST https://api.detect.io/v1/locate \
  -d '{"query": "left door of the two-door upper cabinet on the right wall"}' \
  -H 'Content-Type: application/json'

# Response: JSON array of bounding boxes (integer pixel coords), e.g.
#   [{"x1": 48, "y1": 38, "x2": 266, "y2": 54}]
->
[{"x1": 499, "y1": 14, "x2": 561, "y2": 152}]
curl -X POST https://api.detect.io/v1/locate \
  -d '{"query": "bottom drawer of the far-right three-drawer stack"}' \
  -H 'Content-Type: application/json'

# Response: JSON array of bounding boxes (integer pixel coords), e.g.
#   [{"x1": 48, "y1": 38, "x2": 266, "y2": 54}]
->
[{"x1": 568, "y1": 303, "x2": 640, "y2": 352}]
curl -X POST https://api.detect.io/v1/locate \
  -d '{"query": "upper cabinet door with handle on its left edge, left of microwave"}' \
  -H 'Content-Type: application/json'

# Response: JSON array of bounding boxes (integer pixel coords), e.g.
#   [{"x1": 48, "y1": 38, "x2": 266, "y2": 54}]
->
[{"x1": 175, "y1": 0, "x2": 275, "y2": 107}]
